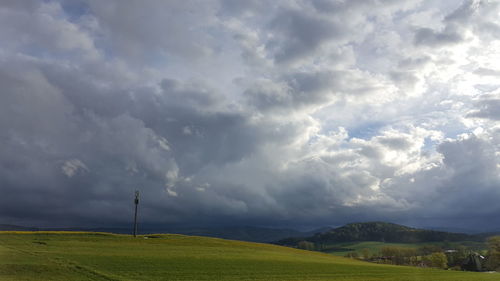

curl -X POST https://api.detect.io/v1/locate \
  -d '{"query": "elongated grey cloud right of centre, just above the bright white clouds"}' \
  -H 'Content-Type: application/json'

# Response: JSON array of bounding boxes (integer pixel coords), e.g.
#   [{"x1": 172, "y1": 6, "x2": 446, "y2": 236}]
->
[{"x1": 244, "y1": 69, "x2": 395, "y2": 114}]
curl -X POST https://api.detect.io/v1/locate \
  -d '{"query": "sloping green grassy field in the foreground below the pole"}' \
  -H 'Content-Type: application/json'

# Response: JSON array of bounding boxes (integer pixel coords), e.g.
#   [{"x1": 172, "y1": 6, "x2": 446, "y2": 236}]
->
[{"x1": 0, "y1": 232, "x2": 500, "y2": 281}]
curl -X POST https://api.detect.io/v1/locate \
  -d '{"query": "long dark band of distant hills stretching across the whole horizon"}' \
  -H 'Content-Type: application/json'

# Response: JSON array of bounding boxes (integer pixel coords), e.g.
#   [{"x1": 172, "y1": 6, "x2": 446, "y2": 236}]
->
[{"x1": 0, "y1": 222, "x2": 494, "y2": 246}]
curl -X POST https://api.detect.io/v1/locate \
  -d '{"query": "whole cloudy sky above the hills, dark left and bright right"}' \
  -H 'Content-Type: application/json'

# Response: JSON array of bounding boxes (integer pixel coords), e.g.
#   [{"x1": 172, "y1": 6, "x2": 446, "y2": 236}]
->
[{"x1": 0, "y1": 0, "x2": 500, "y2": 230}]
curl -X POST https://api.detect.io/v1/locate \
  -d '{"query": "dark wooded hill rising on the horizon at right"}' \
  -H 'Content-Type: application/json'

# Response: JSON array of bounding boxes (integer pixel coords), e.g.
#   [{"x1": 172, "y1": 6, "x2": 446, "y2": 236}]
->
[{"x1": 276, "y1": 222, "x2": 484, "y2": 246}]
